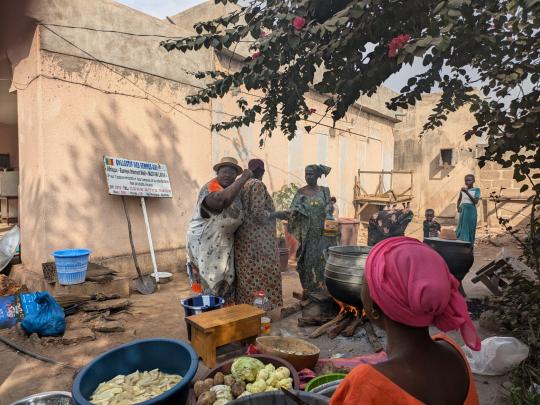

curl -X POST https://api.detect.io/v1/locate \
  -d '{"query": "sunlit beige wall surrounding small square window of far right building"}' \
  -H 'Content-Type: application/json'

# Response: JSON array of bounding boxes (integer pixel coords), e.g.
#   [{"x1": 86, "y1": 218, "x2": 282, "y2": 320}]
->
[{"x1": 394, "y1": 94, "x2": 476, "y2": 223}]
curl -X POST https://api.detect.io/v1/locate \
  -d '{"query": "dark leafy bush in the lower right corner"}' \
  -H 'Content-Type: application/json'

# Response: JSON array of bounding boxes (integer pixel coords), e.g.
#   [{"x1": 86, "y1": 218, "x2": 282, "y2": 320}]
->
[{"x1": 490, "y1": 271, "x2": 540, "y2": 405}]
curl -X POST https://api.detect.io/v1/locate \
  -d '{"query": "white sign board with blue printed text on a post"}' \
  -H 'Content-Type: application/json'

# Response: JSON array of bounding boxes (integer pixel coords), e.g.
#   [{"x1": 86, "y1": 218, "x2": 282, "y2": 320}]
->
[{"x1": 103, "y1": 156, "x2": 172, "y2": 197}]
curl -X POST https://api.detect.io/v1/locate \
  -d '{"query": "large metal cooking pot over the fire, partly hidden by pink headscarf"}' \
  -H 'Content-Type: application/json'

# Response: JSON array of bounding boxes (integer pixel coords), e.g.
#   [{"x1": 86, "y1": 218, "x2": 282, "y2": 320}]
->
[{"x1": 324, "y1": 246, "x2": 371, "y2": 309}]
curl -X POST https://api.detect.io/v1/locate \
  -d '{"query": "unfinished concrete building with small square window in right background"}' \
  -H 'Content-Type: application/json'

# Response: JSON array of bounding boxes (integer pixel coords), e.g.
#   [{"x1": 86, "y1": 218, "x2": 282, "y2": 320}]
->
[{"x1": 394, "y1": 94, "x2": 531, "y2": 232}]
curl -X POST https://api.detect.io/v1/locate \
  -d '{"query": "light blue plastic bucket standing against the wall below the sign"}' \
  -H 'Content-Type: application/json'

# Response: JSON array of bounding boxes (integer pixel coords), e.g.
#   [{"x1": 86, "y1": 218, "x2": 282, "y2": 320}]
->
[{"x1": 53, "y1": 249, "x2": 91, "y2": 285}]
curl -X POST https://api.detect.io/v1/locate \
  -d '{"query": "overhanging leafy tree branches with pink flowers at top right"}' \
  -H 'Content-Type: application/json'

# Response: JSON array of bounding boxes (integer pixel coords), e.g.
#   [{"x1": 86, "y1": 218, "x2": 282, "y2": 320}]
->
[{"x1": 162, "y1": 0, "x2": 540, "y2": 193}]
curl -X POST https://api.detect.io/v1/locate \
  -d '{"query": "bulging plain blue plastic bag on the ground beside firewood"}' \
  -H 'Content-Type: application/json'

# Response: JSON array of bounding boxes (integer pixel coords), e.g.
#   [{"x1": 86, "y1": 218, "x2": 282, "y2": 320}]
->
[{"x1": 21, "y1": 292, "x2": 66, "y2": 336}]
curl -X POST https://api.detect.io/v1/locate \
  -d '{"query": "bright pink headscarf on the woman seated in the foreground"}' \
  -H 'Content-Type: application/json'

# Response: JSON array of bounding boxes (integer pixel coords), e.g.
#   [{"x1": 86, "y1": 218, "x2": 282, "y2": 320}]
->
[{"x1": 366, "y1": 236, "x2": 480, "y2": 350}]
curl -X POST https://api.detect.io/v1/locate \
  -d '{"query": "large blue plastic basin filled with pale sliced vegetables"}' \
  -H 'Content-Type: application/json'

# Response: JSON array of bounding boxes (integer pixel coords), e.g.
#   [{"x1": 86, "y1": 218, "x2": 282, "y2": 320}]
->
[{"x1": 72, "y1": 338, "x2": 199, "y2": 405}]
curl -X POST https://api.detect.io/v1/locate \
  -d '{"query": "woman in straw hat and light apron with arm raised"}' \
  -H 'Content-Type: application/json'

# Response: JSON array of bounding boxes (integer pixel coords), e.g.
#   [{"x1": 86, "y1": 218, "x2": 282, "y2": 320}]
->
[{"x1": 187, "y1": 157, "x2": 252, "y2": 303}]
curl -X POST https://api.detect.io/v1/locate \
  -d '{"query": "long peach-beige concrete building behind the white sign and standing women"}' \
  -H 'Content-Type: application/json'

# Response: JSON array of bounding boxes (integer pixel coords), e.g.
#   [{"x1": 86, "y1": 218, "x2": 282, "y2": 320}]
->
[{"x1": 0, "y1": 0, "x2": 399, "y2": 275}]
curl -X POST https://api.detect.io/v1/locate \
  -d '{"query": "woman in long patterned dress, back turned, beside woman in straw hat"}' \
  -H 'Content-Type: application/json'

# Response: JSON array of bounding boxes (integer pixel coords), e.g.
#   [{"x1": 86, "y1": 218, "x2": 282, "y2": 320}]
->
[{"x1": 234, "y1": 159, "x2": 287, "y2": 309}]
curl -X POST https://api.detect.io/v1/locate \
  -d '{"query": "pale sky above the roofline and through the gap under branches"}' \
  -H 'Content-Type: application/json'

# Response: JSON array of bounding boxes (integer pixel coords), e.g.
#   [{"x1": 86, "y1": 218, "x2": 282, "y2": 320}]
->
[{"x1": 115, "y1": 0, "x2": 425, "y2": 92}]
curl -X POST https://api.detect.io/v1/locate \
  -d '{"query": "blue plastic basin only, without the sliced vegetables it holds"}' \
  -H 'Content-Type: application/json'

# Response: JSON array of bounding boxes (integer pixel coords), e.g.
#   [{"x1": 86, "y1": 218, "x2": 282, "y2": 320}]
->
[{"x1": 72, "y1": 339, "x2": 199, "y2": 405}]
